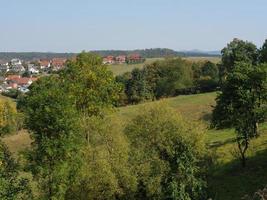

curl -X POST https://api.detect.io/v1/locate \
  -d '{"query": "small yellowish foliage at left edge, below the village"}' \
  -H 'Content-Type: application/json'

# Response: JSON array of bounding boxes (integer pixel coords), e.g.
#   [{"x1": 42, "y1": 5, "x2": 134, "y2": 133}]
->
[{"x1": 0, "y1": 98, "x2": 17, "y2": 135}]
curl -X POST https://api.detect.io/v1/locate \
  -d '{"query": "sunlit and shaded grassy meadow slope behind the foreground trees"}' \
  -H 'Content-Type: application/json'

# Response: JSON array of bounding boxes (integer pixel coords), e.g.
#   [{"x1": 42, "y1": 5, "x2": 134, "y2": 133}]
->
[{"x1": 4, "y1": 93, "x2": 267, "y2": 200}]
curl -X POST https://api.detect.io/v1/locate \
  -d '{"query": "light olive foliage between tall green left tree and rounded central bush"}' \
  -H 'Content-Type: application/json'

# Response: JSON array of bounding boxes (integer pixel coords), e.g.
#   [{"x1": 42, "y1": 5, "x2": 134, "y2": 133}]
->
[{"x1": 68, "y1": 117, "x2": 136, "y2": 200}]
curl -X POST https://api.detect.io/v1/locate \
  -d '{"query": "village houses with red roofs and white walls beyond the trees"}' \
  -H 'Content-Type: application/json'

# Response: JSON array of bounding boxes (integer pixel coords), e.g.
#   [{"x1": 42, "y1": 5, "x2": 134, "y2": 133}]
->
[{"x1": 0, "y1": 54, "x2": 145, "y2": 93}]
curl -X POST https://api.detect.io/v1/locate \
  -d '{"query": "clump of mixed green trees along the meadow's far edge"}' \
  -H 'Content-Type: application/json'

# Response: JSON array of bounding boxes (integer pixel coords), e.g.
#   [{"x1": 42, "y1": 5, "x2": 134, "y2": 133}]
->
[{"x1": 116, "y1": 58, "x2": 219, "y2": 104}]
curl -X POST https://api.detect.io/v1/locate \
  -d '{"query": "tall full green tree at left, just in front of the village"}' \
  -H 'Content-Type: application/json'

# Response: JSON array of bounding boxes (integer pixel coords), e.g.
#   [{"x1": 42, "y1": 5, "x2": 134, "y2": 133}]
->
[{"x1": 20, "y1": 76, "x2": 81, "y2": 200}]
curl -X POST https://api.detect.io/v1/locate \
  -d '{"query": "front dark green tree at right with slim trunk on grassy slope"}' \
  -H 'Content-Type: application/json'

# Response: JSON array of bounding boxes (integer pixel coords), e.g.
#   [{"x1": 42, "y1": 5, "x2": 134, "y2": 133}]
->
[{"x1": 212, "y1": 62, "x2": 267, "y2": 167}]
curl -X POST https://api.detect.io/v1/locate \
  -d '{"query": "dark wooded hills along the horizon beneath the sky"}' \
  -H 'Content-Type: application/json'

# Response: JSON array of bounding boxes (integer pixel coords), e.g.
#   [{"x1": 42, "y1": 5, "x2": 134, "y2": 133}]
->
[{"x1": 0, "y1": 48, "x2": 220, "y2": 61}]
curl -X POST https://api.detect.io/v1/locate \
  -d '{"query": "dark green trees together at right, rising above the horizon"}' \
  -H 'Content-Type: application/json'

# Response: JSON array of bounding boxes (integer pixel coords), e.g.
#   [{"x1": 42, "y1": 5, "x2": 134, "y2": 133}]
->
[{"x1": 212, "y1": 39, "x2": 267, "y2": 167}]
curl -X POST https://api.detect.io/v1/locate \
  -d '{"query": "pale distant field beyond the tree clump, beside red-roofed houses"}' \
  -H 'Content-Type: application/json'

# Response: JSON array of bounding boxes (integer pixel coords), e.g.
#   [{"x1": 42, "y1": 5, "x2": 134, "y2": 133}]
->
[{"x1": 108, "y1": 57, "x2": 220, "y2": 75}]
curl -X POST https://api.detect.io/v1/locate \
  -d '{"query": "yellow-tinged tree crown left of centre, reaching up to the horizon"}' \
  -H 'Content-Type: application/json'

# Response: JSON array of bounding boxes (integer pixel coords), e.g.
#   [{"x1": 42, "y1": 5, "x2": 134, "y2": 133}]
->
[{"x1": 60, "y1": 52, "x2": 122, "y2": 116}]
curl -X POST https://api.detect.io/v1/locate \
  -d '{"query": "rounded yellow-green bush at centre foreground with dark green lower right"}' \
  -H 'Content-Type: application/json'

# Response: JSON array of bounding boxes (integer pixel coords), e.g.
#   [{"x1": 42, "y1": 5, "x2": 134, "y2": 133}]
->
[{"x1": 125, "y1": 102, "x2": 206, "y2": 199}]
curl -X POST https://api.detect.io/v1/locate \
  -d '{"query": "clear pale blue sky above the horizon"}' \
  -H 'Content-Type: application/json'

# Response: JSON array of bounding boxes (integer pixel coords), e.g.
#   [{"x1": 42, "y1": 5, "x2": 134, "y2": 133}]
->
[{"x1": 0, "y1": 0, "x2": 267, "y2": 52}]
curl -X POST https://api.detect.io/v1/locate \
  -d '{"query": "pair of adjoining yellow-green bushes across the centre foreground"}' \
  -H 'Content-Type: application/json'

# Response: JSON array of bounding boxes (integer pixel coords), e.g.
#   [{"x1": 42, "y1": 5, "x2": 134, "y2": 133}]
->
[{"x1": 66, "y1": 103, "x2": 207, "y2": 200}]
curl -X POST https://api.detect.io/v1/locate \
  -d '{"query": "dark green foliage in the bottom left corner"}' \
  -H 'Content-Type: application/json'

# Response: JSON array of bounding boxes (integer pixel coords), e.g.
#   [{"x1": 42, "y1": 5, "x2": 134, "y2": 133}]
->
[{"x1": 0, "y1": 141, "x2": 33, "y2": 200}]
